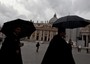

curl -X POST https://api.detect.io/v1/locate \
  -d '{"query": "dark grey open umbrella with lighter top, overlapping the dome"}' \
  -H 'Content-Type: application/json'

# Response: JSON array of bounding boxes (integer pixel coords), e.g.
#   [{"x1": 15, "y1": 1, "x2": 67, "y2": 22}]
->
[{"x1": 53, "y1": 15, "x2": 90, "y2": 29}]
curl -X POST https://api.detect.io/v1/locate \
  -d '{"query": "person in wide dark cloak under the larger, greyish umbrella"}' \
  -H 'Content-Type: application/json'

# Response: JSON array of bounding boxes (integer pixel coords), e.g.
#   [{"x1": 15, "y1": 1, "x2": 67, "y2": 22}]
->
[{"x1": 41, "y1": 27, "x2": 75, "y2": 64}]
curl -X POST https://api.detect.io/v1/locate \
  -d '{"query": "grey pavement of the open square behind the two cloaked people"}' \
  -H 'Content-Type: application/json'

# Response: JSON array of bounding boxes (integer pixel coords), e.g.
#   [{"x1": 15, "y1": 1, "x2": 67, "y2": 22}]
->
[{"x1": 0, "y1": 41, "x2": 90, "y2": 64}]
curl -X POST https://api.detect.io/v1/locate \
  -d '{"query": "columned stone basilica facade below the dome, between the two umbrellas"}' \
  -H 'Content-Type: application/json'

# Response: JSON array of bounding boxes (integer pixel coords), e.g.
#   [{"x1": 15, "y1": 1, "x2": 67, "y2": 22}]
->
[{"x1": 30, "y1": 23, "x2": 57, "y2": 42}]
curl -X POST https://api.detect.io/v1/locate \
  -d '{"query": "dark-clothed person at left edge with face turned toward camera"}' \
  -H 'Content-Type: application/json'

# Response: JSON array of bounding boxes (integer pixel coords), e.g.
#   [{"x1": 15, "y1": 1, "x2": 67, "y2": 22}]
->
[{"x1": 0, "y1": 27, "x2": 24, "y2": 64}]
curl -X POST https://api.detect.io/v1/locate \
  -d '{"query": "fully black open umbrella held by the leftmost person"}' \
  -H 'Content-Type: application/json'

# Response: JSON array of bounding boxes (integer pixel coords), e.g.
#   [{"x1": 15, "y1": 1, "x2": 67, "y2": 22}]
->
[{"x1": 1, "y1": 19, "x2": 36, "y2": 38}]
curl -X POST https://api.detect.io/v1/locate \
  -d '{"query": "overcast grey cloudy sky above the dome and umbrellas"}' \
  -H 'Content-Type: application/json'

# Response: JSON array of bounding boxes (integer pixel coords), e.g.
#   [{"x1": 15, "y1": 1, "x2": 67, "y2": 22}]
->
[{"x1": 0, "y1": 0, "x2": 90, "y2": 24}]
